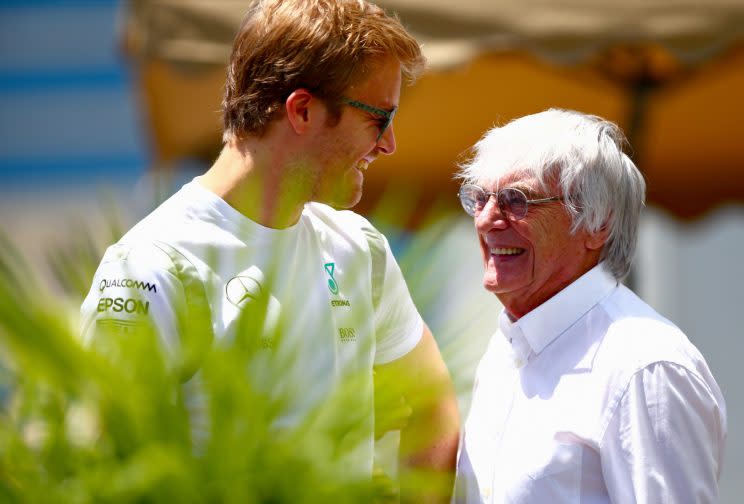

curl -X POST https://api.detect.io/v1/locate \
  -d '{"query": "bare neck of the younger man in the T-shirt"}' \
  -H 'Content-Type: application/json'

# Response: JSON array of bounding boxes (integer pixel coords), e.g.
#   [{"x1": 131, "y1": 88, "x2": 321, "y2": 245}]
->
[{"x1": 199, "y1": 141, "x2": 309, "y2": 229}]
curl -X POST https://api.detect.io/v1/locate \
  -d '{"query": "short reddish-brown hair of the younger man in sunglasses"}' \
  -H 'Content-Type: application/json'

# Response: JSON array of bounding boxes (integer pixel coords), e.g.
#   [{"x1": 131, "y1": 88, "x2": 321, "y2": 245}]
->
[{"x1": 222, "y1": 0, "x2": 425, "y2": 141}]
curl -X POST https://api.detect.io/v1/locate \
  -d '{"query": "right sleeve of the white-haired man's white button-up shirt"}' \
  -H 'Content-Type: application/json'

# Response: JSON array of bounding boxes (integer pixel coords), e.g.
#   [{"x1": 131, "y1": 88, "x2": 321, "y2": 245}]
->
[{"x1": 600, "y1": 362, "x2": 726, "y2": 503}]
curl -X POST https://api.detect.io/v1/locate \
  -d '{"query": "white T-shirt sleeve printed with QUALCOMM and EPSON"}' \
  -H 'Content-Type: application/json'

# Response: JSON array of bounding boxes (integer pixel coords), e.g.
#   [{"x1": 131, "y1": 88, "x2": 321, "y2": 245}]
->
[{"x1": 80, "y1": 244, "x2": 206, "y2": 378}]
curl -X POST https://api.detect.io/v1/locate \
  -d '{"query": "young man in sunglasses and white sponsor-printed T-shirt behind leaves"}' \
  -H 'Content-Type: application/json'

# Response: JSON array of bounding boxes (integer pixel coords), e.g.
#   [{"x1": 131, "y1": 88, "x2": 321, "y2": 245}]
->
[{"x1": 82, "y1": 0, "x2": 459, "y2": 496}]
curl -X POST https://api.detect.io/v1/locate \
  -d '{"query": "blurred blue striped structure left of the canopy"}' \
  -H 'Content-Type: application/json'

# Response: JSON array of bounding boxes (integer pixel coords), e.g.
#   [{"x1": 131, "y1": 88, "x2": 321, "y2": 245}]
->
[{"x1": 0, "y1": 0, "x2": 149, "y2": 194}]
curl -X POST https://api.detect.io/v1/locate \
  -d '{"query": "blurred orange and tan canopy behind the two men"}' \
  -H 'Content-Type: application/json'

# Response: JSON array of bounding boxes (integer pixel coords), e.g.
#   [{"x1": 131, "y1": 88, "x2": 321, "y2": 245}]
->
[{"x1": 127, "y1": 0, "x2": 744, "y2": 217}]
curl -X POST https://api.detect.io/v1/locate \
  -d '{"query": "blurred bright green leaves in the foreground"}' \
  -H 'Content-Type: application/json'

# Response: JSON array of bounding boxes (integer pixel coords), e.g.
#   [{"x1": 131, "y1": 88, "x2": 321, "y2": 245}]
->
[{"x1": 0, "y1": 196, "x2": 462, "y2": 504}]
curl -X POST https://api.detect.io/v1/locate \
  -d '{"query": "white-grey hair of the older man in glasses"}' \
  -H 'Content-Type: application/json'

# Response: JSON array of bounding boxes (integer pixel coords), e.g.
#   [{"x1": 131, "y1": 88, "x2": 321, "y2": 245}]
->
[{"x1": 457, "y1": 109, "x2": 646, "y2": 280}]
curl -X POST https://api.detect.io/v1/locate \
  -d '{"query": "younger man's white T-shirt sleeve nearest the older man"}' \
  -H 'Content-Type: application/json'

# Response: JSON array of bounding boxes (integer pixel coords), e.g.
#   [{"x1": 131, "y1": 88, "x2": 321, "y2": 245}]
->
[{"x1": 373, "y1": 235, "x2": 424, "y2": 364}]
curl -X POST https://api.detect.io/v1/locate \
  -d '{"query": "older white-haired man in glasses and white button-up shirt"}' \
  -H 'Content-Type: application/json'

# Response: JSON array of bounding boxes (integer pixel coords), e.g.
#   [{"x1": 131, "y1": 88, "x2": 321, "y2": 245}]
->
[{"x1": 456, "y1": 110, "x2": 726, "y2": 503}]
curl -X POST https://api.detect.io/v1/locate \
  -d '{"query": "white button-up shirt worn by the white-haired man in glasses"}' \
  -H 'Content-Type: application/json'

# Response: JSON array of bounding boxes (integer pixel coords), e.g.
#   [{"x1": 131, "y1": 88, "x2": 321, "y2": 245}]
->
[{"x1": 454, "y1": 264, "x2": 726, "y2": 504}]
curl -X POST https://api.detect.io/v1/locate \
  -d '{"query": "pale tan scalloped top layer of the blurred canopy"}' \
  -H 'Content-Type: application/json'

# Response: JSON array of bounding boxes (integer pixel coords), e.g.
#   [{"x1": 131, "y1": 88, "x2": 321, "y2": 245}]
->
[{"x1": 129, "y1": 0, "x2": 744, "y2": 68}]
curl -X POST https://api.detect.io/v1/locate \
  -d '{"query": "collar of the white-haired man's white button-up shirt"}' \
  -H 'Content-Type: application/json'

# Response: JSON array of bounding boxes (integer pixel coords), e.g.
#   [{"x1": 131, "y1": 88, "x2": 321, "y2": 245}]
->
[{"x1": 499, "y1": 263, "x2": 617, "y2": 367}]
